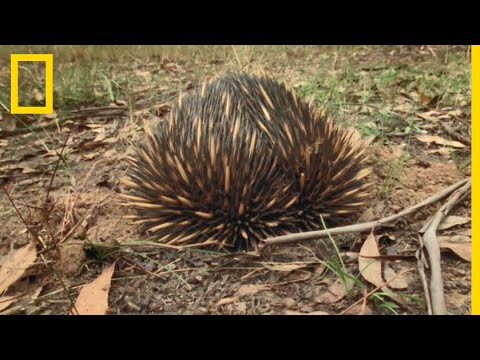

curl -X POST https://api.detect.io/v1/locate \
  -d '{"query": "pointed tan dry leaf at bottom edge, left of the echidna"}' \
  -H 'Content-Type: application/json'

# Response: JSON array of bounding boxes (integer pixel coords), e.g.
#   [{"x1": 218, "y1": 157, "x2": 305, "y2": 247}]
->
[{"x1": 75, "y1": 263, "x2": 115, "y2": 315}]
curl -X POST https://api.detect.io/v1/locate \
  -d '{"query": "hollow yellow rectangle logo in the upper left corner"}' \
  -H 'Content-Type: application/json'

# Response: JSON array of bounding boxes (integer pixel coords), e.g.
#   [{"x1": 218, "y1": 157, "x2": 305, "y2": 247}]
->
[{"x1": 10, "y1": 54, "x2": 53, "y2": 114}]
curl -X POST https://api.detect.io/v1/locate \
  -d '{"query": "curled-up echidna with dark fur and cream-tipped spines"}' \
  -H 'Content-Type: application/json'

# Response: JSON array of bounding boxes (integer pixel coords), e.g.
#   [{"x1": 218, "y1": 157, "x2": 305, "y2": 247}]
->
[{"x1": 124, "y1": 74, "x2": 369, "y2": 248}]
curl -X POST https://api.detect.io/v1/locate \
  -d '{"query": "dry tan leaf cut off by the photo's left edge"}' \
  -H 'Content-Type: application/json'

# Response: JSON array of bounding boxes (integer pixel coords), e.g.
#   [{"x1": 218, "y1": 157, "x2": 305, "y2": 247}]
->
[{"x1": 0, "y1": 241, "x2": 37, "y2": 294}]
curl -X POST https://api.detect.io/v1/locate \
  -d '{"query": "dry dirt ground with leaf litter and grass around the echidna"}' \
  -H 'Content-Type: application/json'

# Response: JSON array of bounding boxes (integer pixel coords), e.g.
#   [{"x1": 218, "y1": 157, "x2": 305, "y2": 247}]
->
[{"x1": 0, "y1": 46, "x2": 471, "y2": 314}]
